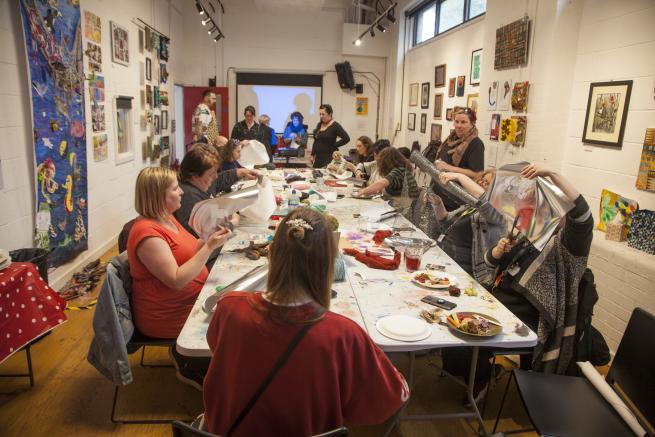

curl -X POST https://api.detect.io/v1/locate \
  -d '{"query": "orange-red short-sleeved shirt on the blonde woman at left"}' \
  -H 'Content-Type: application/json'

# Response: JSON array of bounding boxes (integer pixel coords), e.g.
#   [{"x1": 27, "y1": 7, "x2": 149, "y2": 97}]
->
[{"x1": 127, "y1": 215, "x2": 208, "y2": 338}]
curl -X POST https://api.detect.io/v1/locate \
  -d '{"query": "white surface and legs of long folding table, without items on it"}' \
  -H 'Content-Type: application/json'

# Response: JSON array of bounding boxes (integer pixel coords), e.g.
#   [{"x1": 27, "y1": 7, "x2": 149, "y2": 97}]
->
[{"x1": 177, "y1": 174, "x2": 537, "y2": 434}]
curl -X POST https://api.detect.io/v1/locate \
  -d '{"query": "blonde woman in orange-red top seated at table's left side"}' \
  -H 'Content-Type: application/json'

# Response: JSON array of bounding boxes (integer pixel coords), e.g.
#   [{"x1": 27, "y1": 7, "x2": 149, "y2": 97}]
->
[{"x1": 127, "y1": 167, "x2": 231, "y2": 338}]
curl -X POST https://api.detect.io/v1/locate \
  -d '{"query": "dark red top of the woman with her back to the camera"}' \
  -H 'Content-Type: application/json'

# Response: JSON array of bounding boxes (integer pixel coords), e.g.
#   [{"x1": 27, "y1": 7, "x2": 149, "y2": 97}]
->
[{"x1": 203, "y1": 292, "x2": 409, "y2": 436}]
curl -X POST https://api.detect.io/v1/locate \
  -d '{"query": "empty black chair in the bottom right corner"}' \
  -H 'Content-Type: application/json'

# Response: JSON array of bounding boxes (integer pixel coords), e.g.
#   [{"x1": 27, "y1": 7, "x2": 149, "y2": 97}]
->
[{"x1": 493, "y1": 308, "x2": 655, "y2": 437}]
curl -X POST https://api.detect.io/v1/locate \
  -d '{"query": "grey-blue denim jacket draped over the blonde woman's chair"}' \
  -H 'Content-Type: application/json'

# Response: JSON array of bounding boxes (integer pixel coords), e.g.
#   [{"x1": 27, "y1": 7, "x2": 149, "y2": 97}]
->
[{"x1": 86, "y1": 252, "x2": 134, "y2": 385}]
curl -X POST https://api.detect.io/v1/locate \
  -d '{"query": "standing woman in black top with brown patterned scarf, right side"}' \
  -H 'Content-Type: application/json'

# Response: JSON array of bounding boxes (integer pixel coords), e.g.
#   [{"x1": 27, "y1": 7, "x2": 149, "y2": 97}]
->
[{"x1": 433, "y1": 108, "x2": 484, "y2": 211}]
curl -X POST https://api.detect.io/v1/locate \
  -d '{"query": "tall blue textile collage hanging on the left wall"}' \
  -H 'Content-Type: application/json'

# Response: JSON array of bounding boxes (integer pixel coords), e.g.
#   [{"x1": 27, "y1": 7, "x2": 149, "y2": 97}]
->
[{"x1": 19, "y1": 0, "x2": 88, "y2": 267}]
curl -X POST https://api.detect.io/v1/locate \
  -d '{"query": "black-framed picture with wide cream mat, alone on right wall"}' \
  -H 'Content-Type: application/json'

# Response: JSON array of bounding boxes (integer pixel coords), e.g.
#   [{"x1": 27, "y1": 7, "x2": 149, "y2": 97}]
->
[{"x1": 582, "y1": 80, "x2": 632, "y2": 148}]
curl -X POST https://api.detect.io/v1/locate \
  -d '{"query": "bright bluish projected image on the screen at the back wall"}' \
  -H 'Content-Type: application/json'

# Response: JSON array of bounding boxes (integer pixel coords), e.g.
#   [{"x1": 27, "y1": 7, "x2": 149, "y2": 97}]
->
[{"x1": 237, "y1": 84, "x2": 321, "y2": 133}]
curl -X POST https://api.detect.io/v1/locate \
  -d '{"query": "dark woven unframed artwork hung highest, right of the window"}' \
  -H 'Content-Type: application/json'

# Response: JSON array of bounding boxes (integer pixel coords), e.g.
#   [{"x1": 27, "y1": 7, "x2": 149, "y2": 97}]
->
[{"x1": 494, "y1": 16, "x2": 530, "y2": 70}]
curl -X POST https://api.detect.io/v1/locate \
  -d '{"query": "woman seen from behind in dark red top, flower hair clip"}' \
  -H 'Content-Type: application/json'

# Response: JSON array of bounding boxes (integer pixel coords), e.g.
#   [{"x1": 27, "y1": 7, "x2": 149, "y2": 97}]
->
[{"x1": 203, "y1": 208, "x2": 409, "y2": 436}]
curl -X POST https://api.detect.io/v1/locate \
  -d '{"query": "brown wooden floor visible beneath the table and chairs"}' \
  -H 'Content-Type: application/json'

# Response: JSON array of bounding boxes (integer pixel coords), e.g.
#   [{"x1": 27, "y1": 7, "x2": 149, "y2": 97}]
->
[{"x1": 0, "y1": 248, "x2": 536, "y2": 437}]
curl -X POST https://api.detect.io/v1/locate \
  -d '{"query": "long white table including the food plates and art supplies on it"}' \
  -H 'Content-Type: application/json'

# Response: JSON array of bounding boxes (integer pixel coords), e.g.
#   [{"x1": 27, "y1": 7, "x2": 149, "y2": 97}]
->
[{"x1": 177, "y1": 169, "x2": 537, "y2": 432}]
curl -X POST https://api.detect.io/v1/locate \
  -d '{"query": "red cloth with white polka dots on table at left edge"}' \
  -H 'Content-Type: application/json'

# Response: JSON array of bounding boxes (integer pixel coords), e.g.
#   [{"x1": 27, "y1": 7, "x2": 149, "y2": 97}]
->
[{"x1": 0, "y1": 263, "x2": 68, "y2": 363}]
